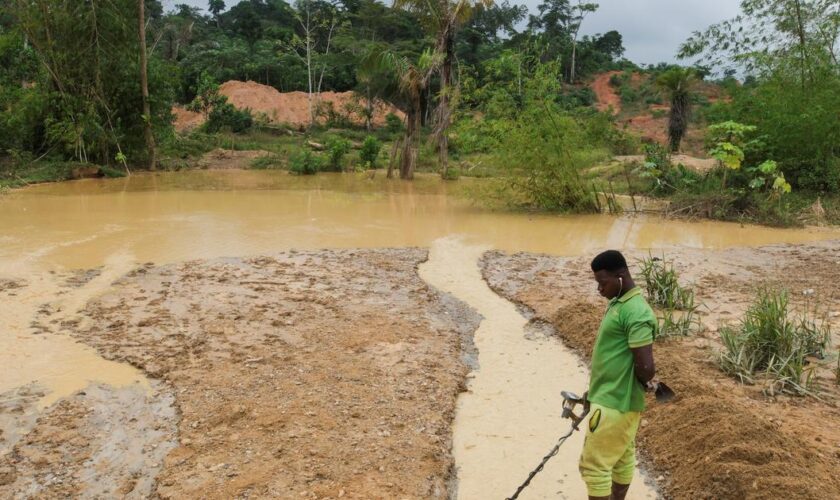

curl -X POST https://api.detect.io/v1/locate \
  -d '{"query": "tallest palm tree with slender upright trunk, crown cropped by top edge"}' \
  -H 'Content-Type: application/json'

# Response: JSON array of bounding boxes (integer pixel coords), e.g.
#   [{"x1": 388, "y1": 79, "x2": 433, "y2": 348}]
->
[{"x1": 394, "y1": 0, "x2": 493, "y2": 177}]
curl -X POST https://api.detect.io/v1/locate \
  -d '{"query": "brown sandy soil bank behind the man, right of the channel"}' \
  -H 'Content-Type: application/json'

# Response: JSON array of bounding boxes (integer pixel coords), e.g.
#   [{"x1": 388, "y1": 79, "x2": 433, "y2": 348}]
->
[{"x1": 482, "y1": 242, "x2": 840, "y2": 499}]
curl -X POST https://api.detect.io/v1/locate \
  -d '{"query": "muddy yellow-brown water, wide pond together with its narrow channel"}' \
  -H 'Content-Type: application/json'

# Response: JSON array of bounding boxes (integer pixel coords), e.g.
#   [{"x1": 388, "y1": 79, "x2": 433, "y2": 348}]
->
[{"x1": 0, "y1": 171, "x2": 840, "y2": 499}]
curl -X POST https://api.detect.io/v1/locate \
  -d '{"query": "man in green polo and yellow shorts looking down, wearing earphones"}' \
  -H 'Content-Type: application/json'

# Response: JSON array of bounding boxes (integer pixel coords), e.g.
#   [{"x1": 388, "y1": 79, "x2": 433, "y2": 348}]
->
[{"x1": 580, "y1": 250, "x2": 657, "y2": 500}]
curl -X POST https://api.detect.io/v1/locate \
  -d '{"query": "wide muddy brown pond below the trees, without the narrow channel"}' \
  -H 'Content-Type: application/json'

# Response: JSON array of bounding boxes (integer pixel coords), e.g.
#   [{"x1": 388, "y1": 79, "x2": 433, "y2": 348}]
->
[{"x1": 0, "y1": 171, "x2": 838, "y2": 496}]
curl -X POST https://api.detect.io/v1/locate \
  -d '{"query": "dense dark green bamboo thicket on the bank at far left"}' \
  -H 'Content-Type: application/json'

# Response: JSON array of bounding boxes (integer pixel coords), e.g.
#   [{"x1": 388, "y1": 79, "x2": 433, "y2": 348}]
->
[{"x1": 0, "y1": 0, "x2": 173, "y2": 168}]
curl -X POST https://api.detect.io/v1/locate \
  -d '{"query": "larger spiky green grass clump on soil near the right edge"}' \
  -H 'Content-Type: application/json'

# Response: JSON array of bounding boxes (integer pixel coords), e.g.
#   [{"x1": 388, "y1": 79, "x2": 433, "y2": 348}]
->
[{"x1": 720, "y1": 289, "x2": 831, "y2": 395}]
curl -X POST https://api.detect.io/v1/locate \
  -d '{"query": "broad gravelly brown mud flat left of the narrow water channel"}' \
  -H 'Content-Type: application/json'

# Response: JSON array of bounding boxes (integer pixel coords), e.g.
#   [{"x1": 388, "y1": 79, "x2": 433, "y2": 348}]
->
[{"x1": 23, "y1": 249, "x2": 479, "y2": 498}]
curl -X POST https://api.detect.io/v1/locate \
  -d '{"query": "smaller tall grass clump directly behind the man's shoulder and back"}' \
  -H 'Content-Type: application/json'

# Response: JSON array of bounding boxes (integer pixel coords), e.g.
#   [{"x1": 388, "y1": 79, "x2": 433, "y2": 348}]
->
[{"x1": 639, "y1": 256, "x2": 700, "y2": 338}]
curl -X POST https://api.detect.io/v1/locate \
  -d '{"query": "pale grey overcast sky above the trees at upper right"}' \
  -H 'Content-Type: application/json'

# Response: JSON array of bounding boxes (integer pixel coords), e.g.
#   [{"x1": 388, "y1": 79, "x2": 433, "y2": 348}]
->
[{"x1": 164, "y1": 0, "x2": 740, "y2": 64}]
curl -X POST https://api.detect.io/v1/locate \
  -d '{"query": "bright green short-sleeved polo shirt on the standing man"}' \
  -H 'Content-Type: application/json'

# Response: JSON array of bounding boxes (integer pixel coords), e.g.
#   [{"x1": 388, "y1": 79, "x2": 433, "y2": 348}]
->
[{"x1": 589, "y1": 287, "x2": 657, "y2": 412}]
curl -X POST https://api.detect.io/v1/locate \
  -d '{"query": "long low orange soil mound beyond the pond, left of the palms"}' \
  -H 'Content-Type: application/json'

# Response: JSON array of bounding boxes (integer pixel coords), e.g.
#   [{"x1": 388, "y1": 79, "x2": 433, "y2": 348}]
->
[{"x1": 173, "y1": 80, "x2": 405, "y2": 132}]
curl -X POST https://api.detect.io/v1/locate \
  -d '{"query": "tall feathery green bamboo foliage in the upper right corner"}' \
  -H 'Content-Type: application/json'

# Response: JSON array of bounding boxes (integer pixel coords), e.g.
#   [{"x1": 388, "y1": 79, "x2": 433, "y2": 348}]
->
[{"x1": 681, "y1": 0, "x2": 840, "y2": 192}]
